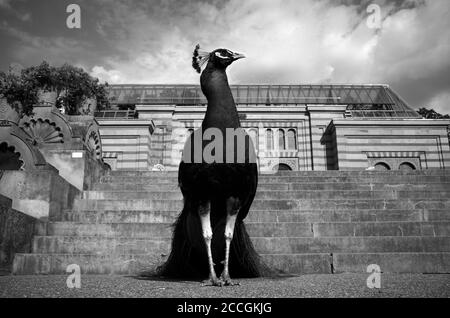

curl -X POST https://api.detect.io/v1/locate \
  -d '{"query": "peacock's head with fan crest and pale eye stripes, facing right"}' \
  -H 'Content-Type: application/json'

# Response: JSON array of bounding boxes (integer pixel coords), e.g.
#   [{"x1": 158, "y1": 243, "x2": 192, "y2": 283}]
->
[{"x1": 192, "y1": 44, "x2": 245, "y2": 73}]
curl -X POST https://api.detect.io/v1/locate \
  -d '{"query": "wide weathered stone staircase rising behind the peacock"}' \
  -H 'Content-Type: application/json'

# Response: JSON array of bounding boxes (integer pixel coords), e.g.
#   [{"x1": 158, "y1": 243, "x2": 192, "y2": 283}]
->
[{"x1": 13, "y1": 170, "x2": 450, "y2": 274}]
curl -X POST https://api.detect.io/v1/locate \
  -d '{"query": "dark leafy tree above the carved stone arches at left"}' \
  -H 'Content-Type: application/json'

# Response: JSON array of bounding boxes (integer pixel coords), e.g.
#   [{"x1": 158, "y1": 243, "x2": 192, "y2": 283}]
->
[{"x1": 0, "y1": 61, "x2": 109, "y2": 115}]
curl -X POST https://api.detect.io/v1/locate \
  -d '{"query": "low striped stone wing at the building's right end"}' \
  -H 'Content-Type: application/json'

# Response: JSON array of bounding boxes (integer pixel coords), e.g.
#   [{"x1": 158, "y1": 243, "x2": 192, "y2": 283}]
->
[{"x1": 326, "y1": 119, "x2": 450, "y2": 170}]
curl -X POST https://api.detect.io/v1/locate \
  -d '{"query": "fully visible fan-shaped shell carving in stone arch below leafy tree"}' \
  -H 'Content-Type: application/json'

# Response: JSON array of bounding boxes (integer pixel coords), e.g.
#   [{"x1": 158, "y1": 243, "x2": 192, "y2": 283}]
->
[{"x1": 22, "y1": 118, "x2": 64, "y2": 145}]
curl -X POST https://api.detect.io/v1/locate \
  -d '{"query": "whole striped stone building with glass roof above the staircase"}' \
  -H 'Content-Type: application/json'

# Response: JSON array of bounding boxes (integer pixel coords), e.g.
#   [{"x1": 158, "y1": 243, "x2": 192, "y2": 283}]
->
[{"x1": 96, "y1": 85, "x2": 450, "y2": 171}]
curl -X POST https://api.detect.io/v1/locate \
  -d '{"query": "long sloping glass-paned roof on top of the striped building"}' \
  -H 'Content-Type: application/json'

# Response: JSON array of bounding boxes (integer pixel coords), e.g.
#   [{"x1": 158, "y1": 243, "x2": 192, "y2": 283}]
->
[{"x1": 109, "y1": 84, "x2": 420, "y2": 118}]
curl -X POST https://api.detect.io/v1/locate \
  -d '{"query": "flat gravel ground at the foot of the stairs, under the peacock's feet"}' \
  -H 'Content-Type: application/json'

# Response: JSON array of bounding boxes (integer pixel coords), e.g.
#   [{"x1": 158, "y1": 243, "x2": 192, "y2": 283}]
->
[{"x1": 0, "y1": 274, "x2": 450, "y2": 298}]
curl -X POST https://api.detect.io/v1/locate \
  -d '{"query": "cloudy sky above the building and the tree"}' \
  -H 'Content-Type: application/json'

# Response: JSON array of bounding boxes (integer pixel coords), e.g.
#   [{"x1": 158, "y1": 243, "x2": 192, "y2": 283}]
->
[{"x1": 0, "y1": 0, "x2": 450, "y2": 113}]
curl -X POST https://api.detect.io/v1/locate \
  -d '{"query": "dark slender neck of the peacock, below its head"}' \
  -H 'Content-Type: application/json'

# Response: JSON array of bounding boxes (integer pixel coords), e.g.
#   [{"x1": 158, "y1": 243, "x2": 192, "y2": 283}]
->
[{"x1": 200, "y1": 64, "x2": 241, "y2": 130}]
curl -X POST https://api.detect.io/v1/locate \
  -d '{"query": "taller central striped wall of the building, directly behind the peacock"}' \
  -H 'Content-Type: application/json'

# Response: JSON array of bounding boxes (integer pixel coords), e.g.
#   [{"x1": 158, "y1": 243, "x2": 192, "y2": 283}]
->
[{"x1": 135, "y1": 105, "x2": 314, "y2": 171}]
